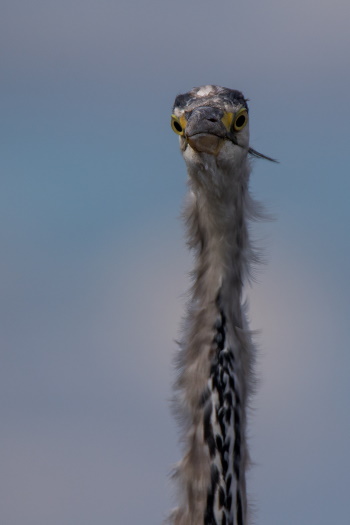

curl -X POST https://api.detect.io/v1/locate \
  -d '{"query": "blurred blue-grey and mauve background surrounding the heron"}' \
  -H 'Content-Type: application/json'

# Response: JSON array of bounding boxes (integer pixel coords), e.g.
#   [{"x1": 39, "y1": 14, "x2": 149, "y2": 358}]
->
[{"x1": 0, "y1": 0, "x2": 350, "y2": 525}]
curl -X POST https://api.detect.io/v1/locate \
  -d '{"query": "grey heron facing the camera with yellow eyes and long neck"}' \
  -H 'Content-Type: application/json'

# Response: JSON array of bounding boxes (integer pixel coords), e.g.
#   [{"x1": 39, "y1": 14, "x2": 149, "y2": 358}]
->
[{"x1": 167, "y1": 85, "x2": 277, "y2": 525}]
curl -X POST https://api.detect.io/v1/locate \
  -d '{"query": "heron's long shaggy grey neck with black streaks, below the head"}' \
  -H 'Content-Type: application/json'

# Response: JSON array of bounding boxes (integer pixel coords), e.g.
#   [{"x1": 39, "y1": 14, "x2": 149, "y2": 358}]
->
[{"x1": 173, "y1": 159, "x2": 253, "y2": 525}]
